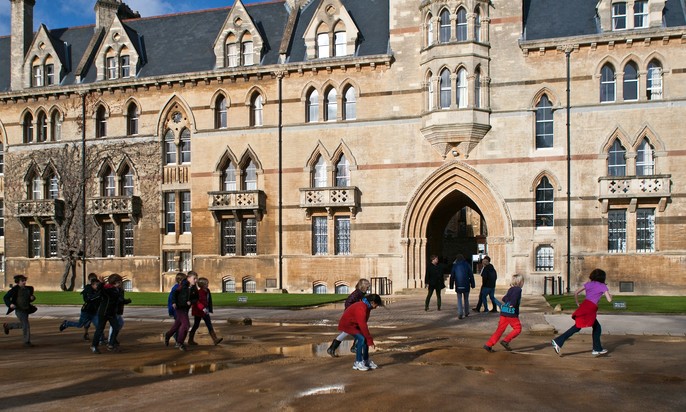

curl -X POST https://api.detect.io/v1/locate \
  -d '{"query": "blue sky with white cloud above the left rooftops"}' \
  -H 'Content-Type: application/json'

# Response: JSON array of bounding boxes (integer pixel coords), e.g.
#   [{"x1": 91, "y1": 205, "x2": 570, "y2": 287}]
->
[{"x1": 0, "y1": 0, "x2": 269, "y2": 36}]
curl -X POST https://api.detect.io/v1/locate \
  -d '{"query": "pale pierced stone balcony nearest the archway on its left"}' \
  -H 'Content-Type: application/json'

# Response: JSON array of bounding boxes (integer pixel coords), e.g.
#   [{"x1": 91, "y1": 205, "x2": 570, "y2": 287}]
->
[{"x1": 300, "y1": 186, "x2": 361, "y2": 219}]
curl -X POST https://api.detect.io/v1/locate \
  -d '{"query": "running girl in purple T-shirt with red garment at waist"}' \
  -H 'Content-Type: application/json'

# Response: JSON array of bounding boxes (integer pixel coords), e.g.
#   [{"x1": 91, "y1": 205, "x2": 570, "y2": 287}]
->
[{"x1": 552, "y1": 269, "x2": 612, "y2": 356}]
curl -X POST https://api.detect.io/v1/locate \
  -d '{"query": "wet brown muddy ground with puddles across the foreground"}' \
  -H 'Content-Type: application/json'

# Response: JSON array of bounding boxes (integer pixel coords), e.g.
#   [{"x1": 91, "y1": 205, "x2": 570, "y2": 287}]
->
[{"x1": 0, "y1": 298, "x2": 686, "y2": 411}]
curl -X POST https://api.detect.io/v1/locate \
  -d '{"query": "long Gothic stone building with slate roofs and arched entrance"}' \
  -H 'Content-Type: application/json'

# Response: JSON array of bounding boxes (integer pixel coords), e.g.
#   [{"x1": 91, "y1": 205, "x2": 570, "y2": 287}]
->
[{"x1": 0, "y1": 0, "x2": 686, "y2": 294}]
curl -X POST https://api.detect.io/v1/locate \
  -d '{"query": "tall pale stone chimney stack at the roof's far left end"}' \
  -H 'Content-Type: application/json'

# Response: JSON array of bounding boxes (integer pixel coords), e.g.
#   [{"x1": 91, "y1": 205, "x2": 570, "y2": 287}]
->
[{"x1": 10, "y1": 0, "x2": 36, "y2": 90}]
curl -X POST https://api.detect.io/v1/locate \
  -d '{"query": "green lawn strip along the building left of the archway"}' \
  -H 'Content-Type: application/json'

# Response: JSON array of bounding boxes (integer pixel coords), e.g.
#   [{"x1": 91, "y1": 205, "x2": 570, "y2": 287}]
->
[{"x1": 34, "y1": 292, "x2": 348, "y2": 308}]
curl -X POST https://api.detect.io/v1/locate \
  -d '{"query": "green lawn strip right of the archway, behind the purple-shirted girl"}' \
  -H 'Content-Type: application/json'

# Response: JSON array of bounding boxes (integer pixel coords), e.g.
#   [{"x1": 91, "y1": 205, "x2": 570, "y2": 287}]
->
[{"x1": 545, "y1": 294, "x2": 686, "y2": 314}]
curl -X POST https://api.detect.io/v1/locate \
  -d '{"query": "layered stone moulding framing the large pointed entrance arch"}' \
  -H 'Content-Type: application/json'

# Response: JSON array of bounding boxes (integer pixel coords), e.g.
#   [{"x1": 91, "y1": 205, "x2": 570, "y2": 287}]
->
[{"x1": 400, "y1": 161, "x2": 513, "y2": 288}]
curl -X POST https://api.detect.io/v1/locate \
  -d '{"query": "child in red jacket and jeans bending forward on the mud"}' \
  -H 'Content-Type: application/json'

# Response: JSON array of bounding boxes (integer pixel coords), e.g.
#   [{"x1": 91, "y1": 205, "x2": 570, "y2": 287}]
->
[{"x1": 338, "y1": 294, "x2": 383, "y2": 371}]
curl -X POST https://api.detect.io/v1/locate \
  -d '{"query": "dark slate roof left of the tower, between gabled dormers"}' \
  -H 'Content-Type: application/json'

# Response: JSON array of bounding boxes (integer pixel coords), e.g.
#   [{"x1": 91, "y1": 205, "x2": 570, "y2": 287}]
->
[{"x1": 0, "y1": 0, "x2": 389, "y2": 92}]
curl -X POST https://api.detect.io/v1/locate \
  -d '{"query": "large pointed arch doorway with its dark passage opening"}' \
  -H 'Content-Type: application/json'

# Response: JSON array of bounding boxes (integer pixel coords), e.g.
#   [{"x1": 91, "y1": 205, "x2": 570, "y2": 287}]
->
[{"x1": 401, "y1": 161, "x2": 513, "y2": 288}]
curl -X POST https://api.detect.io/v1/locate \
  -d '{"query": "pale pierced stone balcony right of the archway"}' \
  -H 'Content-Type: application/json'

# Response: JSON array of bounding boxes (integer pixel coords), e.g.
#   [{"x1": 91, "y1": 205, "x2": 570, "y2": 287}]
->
[{"x1": 598, "y1": 175, "x2": 672, "y2": 213}]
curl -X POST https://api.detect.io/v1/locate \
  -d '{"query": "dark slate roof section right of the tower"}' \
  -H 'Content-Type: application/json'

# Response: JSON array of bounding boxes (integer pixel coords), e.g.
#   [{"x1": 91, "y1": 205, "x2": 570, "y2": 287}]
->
[{"x1": 522, "y1": 0, "x2": 686, "y2": 41}]
